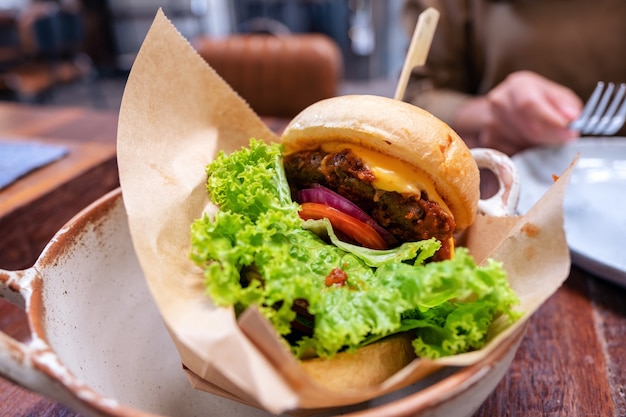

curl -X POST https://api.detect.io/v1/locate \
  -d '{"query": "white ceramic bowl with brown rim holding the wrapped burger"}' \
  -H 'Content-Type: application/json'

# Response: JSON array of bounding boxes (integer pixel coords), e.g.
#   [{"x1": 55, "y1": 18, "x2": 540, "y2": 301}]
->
[{"x1": 0, "y1": 189, "x2": 523, "y2": 417}]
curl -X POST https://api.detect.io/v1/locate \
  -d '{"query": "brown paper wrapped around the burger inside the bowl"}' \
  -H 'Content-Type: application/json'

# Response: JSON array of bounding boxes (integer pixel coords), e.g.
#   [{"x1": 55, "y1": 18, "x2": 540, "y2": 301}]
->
[{"x1": 118, "y1": 11, "x2": 572, "y2": 413}]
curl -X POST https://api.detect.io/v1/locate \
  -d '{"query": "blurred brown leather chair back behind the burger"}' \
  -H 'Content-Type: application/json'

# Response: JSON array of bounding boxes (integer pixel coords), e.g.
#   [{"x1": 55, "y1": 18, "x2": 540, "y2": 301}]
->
[{"x1": 193, "y1": 33, "x2": 343, "y2": 118}]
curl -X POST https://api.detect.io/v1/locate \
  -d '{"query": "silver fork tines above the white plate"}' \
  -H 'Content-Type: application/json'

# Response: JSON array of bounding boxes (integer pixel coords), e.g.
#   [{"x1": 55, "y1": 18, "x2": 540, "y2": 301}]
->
[{"x1": 569, "y1": 81, "x2": 626, "y2": 136}]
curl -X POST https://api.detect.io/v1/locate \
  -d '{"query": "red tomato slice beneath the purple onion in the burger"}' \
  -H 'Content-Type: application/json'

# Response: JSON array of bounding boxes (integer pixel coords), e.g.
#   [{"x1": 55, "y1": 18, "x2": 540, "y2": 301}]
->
[{"x1": 300, "y1": 203, "x2": 388, "y2": 249}]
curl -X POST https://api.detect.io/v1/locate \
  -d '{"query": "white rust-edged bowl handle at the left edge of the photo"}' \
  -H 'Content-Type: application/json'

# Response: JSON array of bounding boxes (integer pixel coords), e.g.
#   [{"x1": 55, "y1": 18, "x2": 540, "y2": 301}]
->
[{"x1": 0, "y1": 267, "x2": 70, "y2": 400}]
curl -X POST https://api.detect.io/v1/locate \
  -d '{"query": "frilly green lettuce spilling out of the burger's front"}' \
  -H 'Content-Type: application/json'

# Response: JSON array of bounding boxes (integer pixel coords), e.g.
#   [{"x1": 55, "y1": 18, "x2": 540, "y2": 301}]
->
[{"x1": 190, "y1": 139, "x2": 519, "y2": 357}]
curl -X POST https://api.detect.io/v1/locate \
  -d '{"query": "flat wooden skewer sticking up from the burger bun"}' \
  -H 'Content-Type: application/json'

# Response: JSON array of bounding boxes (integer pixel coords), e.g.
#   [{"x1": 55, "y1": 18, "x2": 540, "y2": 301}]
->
[{"x1": 394, "y1": 7, "x2": 439, "y2": 100}]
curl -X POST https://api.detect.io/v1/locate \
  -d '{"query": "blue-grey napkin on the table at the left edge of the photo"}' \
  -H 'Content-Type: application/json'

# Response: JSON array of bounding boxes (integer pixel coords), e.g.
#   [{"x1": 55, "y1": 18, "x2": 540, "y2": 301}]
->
[{"x1": 0, "y1": 139, "x2": 68, "y2": 189}]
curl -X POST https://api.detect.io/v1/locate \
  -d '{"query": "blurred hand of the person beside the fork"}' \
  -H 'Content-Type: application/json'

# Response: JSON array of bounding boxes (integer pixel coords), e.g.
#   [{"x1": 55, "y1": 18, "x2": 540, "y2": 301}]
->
[{"x1": 453, "y1": 71, "x2": 583, "y2": 154}]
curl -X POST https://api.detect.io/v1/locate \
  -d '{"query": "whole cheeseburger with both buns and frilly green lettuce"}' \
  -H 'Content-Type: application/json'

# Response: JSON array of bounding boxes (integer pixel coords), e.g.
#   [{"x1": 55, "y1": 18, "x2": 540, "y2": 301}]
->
[{"x1": 191, "y1": 95, "x2": 519, "y2": 390}]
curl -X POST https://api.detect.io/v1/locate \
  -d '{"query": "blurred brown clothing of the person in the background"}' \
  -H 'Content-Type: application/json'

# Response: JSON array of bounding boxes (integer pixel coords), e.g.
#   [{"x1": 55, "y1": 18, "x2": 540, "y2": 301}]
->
[{"x1": 402, "y1": 0, "x2": 626, "y2": 127}]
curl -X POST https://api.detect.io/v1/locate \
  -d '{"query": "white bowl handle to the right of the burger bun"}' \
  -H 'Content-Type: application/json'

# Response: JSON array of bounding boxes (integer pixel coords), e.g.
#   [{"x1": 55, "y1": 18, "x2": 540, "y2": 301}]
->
[{"x1": 471, "y1": 148, "x2": 520, "y2": 216}]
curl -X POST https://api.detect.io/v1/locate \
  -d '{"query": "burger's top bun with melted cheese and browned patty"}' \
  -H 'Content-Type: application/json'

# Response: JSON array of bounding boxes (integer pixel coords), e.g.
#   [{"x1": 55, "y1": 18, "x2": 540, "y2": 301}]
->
[{"x1": 282, "y1": 95, "x2": 480, "y2": 260}]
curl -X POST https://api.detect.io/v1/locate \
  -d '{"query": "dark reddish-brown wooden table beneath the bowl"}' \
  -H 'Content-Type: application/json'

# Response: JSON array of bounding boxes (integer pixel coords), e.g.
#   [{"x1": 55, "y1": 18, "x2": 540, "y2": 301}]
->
[{"x1": 0, "y1": 104, "x2": 626, "y2": 417}]
